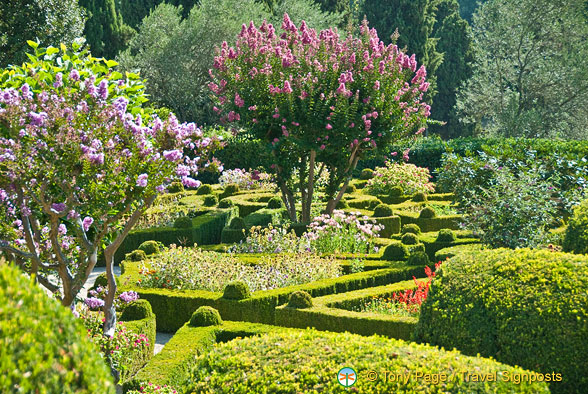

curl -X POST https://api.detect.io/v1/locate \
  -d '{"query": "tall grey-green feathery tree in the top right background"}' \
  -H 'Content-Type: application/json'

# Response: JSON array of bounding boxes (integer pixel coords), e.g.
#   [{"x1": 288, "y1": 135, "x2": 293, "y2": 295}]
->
[{"x1": 456, "y1": 0, "x2": 588, "y2": 138}]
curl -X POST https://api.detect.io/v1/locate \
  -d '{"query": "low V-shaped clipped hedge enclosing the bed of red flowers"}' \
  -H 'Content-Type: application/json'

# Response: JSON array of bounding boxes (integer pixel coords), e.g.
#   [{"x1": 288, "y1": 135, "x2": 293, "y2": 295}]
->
[{"x1": 276, "y1": 278, "x2": 424, "y2": 340}]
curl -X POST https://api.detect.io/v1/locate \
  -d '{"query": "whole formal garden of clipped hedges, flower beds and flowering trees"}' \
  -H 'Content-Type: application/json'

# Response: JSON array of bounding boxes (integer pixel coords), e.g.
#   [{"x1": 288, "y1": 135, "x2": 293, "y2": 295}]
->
[{"x1": 0, "y1": 0, "x2": 588, "y2": 394}]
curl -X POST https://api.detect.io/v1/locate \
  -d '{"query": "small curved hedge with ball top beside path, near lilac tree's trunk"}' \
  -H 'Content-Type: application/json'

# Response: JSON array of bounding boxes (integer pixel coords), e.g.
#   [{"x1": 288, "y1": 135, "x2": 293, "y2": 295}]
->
[{"x1": 120, "y1": 299, "x2": 156, "y2": 382}]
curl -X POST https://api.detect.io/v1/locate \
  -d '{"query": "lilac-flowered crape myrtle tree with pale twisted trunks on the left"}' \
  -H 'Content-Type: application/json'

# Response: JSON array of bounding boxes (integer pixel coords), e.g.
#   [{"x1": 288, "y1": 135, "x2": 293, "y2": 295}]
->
[{"x1": 0, "y1": 42, "x2": 217, "y2": 335}]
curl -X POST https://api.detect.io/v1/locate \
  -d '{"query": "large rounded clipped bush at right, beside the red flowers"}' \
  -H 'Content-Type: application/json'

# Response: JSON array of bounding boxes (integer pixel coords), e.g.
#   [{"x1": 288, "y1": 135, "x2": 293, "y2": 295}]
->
[{"x1": 415, "y1": 249, "x2": 588, "y2": 393}]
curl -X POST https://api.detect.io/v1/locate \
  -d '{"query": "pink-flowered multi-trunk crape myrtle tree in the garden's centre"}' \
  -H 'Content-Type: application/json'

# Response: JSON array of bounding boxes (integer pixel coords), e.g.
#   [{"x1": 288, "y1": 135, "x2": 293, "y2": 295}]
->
[{"x1": 209, "y1": 14, "x2": 430, "y2": 222}]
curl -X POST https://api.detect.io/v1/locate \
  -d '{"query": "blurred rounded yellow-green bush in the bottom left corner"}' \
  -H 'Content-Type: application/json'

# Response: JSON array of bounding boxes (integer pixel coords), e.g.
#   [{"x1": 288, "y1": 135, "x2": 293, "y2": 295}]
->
[{"x1": 0, "y1": 262, "x2": 115, "y2": 393}]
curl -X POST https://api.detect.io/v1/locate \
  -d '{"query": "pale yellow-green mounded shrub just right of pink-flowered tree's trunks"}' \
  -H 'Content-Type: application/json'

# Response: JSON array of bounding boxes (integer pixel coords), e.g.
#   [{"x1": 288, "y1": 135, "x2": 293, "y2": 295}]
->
[{"x1": 366, "y1": 161, "x2": 435, "y2": 195}]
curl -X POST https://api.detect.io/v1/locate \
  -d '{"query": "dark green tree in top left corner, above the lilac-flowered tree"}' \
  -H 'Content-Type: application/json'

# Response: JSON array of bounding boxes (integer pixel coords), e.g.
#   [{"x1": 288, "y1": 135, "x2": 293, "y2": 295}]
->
[{"x1": 0, "y1": 0, "x2": 84, "y2": 68}]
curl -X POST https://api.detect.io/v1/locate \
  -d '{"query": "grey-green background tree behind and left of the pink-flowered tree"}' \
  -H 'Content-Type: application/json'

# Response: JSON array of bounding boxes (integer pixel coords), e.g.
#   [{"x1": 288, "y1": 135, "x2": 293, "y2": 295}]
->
[{"x1": 118, "y1": 0, "x2": 341, "y2": 124}]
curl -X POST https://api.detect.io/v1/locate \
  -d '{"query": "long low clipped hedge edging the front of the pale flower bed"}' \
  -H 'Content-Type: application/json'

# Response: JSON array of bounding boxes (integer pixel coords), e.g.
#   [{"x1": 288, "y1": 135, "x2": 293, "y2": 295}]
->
[{"x1": 120, "y1": 262, "x2": 423, "y2": 332}]
